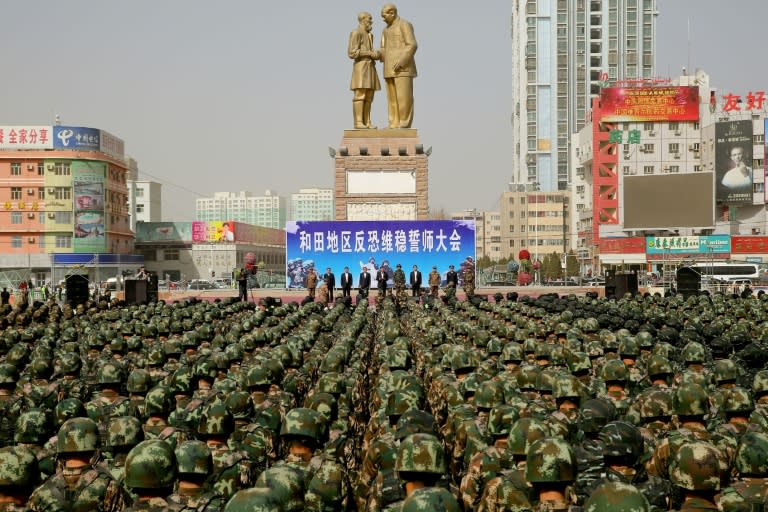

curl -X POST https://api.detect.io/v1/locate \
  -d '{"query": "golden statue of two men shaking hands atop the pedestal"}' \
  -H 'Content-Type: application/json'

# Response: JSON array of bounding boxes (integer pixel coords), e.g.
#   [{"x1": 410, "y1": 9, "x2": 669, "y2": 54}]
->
[{"x1": 348, "y1": 4, "x2": 416, "y2": 129}]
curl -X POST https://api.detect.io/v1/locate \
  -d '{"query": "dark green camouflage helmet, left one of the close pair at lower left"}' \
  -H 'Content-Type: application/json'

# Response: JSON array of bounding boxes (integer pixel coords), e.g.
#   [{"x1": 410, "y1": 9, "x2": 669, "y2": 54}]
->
[{"x1": 125, "y1": 439, "x2": 176, "y2": 489}]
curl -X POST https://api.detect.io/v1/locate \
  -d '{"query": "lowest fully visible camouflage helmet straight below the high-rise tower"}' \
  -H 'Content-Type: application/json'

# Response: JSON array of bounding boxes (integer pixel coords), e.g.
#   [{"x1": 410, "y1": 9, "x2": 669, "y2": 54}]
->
[{"x1": 525, "y1": 437, "x2": 577, "y2": 484}]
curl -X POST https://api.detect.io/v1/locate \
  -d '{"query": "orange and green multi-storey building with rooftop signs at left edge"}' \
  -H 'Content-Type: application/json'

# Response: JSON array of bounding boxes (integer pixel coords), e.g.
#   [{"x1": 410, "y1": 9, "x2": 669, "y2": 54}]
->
[{"x1": 0, "y1": 125, "x2": 140, "y2": 284}]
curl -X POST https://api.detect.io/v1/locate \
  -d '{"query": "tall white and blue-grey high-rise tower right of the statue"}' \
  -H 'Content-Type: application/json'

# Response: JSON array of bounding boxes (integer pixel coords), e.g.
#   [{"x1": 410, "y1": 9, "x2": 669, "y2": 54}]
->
[{"x1": 512, "y1": 0, "x2": 658, "y2": 192}]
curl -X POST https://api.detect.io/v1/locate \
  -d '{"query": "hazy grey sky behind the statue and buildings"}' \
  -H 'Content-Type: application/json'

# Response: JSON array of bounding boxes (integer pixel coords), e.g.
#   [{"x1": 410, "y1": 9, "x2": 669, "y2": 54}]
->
[{"x1": 0, "y1": 0, "x2": 768, "y2": 220}]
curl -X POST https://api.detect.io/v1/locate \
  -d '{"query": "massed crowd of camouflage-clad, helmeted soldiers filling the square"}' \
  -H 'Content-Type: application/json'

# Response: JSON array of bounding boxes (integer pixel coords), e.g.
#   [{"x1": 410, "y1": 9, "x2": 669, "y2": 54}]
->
[{"x1": 0, "y1": 286, "x2": 768, "y2": 512}]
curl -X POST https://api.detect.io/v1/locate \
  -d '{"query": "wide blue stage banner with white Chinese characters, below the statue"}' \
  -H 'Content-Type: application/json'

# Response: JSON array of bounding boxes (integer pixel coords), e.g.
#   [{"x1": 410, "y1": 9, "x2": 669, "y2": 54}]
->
[{"x1": 285, "y1": 220, "x2": 475, "y2": 289}]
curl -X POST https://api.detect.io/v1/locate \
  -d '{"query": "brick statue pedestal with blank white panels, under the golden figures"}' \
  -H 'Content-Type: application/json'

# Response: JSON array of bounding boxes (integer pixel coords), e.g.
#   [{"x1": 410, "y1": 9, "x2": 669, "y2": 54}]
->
[{"x1": 334, "y1": 129, "x2": 429, "y2": 220}]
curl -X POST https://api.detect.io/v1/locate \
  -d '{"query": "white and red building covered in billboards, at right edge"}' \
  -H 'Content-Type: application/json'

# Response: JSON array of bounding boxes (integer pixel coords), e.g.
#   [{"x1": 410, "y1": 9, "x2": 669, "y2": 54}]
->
[{"x1": 571, "y1": 71, "x2": 768, "y2": 274}]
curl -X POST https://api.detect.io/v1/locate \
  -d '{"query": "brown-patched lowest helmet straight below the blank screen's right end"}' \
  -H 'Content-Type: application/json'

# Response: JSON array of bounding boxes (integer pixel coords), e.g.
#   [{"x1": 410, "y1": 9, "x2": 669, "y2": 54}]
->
[{"x1": 669, "y1": 441, "x2": 722, "y2": 491}]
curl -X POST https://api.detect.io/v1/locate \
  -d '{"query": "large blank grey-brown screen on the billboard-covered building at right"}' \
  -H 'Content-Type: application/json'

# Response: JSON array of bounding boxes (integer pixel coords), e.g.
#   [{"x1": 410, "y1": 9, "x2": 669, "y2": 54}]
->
[{"x1": 624, "y1": 172, "x2": 715, "y2": 229}]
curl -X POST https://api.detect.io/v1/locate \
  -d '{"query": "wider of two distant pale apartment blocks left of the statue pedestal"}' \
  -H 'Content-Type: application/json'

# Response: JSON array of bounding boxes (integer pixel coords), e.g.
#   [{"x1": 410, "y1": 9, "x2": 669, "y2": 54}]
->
[{"x1": 195, "y1": 190, "x2": 286, "y2": 229}]
